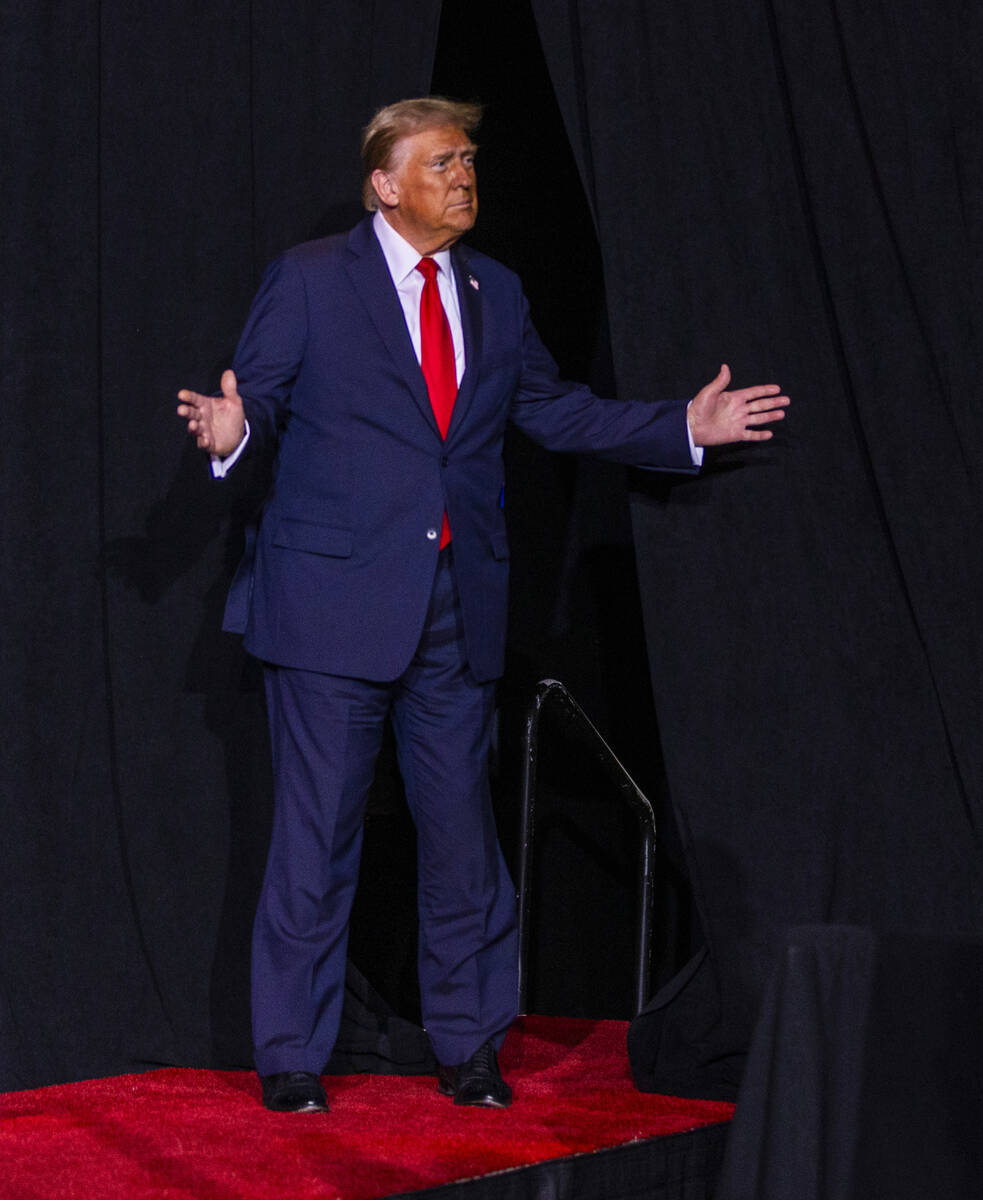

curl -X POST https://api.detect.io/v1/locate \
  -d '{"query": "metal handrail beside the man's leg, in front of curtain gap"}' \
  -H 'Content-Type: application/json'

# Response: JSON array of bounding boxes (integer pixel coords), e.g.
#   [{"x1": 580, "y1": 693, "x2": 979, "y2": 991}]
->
[{"x1": 516, "y1": 679, "x2": 655, "y2": 1013}]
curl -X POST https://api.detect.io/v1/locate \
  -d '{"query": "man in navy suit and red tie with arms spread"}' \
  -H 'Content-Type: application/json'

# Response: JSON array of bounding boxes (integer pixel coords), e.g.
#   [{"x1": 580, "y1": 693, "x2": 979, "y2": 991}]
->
[{"x1": 178, "y1": 97, "x2": 787, "y2": 1111}]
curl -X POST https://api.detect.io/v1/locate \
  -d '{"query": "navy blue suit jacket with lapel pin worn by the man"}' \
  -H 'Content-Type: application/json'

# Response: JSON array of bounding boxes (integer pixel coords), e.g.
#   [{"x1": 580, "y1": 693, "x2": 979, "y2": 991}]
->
[{"x1": 226, "y1": 218, "x2": 693, "y2": 680}]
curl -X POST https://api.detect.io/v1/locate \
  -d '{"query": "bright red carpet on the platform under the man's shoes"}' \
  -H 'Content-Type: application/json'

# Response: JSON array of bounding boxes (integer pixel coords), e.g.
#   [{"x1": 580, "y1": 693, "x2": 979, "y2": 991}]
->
[{"x1": 0, "y1": 1016, "x2": 733, "y2": 1200}]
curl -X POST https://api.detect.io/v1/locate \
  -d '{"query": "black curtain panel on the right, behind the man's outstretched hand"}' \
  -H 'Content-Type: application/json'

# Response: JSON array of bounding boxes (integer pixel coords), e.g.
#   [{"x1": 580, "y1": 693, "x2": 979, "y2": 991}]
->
[{"x1": 533, "y1": 0, "x2": 983, "y2": 1094}]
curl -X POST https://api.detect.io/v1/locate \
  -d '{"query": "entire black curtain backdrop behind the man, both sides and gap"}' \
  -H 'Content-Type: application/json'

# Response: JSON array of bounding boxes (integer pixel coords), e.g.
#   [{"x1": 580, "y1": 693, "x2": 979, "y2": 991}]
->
[{"x1": 0, "y1": 0, "x2": 983, "y2": 1094}]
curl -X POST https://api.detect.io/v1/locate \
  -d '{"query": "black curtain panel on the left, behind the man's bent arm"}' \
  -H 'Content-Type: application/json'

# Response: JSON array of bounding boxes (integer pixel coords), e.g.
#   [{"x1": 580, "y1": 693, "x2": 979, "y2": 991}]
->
[{"x1": 0, "y1": 0, "x2": 439, "y2": 1088}]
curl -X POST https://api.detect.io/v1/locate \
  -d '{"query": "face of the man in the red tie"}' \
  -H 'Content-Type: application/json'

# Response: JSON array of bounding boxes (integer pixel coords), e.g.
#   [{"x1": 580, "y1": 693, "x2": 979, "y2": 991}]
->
[{"x1": 373, "y1": 125, "x2": 478, "y2": 254}]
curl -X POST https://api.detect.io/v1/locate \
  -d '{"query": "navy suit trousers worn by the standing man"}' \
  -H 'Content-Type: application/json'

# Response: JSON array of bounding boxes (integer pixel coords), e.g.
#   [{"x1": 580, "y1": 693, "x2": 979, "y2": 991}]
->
[{"x1": 252, "y1": 542, "x2": 517, "y2": 1075}]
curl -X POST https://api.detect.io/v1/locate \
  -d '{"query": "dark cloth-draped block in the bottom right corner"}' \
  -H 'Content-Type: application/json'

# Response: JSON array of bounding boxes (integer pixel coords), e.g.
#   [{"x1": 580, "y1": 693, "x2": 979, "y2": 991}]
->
[{"x1": 714, "y1": 925, "x2": 983, "y2": 1200}]
